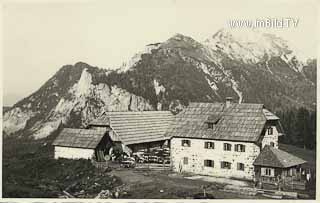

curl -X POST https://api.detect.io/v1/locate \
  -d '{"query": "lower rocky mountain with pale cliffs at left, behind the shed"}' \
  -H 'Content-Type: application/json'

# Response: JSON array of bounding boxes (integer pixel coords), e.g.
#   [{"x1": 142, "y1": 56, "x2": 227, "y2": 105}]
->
[{"x1": 3, "y1": 63, "x2": 153, "y2": 138}]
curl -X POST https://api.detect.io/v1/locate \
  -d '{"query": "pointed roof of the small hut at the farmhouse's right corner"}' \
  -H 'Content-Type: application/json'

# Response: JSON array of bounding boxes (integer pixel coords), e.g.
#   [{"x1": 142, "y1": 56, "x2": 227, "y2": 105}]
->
[{"x1": 253, "y1": 145, "x2": 306, "y2": 168}]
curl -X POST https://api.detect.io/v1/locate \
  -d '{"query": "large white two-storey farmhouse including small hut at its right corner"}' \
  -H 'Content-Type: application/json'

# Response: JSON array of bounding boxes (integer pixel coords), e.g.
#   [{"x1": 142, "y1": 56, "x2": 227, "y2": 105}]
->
[{"x1": 166, "y1": 98, "x2": 305, "y2": 182}]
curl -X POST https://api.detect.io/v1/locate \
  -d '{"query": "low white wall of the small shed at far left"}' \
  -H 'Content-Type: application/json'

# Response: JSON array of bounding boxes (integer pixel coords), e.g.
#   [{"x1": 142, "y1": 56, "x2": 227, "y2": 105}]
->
[{"x1": 54, "y1": 146, "x2": 94, "y2": 159}]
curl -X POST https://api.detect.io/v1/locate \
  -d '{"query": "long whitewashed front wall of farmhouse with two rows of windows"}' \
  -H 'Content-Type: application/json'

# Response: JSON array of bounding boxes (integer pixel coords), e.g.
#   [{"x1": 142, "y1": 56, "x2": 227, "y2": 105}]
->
[{"x1": 170, "y1": 138, "x2": 260, "y2": 180}]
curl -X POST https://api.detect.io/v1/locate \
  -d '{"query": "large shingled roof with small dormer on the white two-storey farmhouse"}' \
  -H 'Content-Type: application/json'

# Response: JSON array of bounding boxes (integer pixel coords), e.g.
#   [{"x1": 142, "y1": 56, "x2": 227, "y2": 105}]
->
[{"x1": 166, "y1": 103, "x2": 273, "y2": 142}]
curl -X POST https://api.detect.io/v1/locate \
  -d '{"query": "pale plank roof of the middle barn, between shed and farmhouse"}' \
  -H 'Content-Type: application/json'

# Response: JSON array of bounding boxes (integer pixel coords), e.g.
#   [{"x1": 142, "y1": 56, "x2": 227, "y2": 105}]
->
[{"x1": 90, "y1": 111, "x2": 173, "y2": 145}]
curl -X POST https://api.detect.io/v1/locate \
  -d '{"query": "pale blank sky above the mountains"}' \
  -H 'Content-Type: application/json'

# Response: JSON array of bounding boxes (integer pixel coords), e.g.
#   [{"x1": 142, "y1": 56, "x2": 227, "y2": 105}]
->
[{"x1": 2, "y1": 0, "x2": 317, "y2": 105}]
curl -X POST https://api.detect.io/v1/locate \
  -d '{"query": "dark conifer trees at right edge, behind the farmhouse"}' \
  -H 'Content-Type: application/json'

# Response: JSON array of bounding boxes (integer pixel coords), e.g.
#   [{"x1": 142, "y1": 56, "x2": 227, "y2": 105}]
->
[{"x1": 276, "y1": 107, "x2": 317, "y2": 150}]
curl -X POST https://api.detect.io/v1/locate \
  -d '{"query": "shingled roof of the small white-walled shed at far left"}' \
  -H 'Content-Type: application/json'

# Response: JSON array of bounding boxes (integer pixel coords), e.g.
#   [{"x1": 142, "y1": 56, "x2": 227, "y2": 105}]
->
[{"x1": 53, "y1": 128, "x2": 107, "y2": 149}]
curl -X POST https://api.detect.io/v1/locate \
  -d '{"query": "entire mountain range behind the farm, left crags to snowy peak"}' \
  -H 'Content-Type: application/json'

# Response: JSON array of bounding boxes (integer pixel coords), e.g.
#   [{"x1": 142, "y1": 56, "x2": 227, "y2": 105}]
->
[{"x1": 3, "y1": 30, "x2": 316, "y2": 138}]
